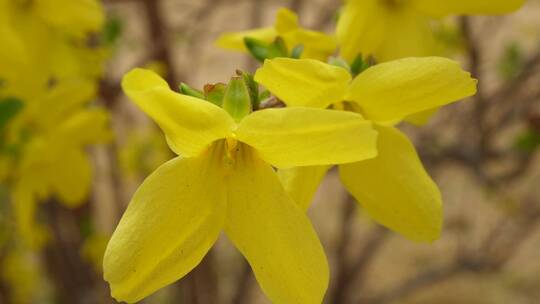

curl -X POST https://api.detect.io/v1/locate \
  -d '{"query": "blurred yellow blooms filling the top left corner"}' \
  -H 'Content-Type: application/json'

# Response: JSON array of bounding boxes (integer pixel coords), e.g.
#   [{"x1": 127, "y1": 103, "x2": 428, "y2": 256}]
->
[{"x1": 0, "y1": 0, "x2": 107, "y2": 100}]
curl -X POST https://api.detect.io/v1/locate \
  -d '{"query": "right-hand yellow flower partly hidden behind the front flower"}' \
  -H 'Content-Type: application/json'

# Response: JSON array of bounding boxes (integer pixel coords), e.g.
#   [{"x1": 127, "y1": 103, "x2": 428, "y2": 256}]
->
[{"x1": 255, "y1": 57, "x2": 476, "y2": 241}]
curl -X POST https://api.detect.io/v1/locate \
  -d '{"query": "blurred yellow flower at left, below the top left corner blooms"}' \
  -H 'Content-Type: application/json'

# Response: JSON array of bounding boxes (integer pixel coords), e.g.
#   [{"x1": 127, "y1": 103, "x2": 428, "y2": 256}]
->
[{"x1": 10, "y1": 81, "x2": 111, "y2": 245}]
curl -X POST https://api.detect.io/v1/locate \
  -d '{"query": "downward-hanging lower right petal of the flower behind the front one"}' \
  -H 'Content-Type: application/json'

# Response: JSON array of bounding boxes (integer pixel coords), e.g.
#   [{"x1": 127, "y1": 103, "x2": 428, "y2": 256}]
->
[{"x1": 340, "y1": 126, "x2": 442, "y2": 242}]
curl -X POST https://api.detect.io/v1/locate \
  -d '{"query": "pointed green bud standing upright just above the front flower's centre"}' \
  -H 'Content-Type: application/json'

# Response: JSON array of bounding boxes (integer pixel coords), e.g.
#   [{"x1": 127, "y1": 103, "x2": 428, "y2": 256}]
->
[{"x1": 223, "y1": 76, "x2": 253, "y2": 122}]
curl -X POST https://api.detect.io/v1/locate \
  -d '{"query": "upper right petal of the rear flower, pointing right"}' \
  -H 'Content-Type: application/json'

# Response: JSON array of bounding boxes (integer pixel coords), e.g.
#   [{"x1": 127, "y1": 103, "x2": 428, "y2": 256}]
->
[{"x1": 346, "y1": 57, "x2": 476, "y2": 122}]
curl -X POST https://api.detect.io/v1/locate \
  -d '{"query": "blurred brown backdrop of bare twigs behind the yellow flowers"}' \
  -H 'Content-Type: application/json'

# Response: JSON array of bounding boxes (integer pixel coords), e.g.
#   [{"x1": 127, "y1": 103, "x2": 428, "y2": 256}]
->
[{"x1": 0, "y1": 0, "x2": 540, "y2": 304}]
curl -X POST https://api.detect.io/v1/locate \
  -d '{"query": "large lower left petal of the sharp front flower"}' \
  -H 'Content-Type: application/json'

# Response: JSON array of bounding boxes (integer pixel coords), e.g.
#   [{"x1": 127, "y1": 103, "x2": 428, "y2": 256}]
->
[{"x1": 103, "y1": 148, "x2": 226, "y2": 302}]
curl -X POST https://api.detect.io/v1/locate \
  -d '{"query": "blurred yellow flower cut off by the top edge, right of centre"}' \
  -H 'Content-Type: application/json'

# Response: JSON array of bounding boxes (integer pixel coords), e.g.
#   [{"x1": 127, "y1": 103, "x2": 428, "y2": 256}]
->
[{"x1": 336, "y1": 0, "x2": 525, "y2": 62}]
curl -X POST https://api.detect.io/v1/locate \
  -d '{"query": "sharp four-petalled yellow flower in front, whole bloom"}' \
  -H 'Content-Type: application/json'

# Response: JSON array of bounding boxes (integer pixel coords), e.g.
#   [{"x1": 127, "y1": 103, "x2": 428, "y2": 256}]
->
[{"x1": 103, "y1": 69, "x2": 376, "y2": 303}]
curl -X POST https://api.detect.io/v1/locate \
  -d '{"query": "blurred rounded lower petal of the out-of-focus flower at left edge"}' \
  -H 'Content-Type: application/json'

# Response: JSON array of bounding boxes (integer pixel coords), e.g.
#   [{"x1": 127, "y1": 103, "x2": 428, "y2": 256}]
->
[{"x1": 47, "y1": 148, "x2": 92, "y2": 208}]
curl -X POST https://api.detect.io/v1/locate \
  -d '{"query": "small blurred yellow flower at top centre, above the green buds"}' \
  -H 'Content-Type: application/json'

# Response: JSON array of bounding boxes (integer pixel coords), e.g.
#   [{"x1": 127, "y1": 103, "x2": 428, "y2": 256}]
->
[{"x1": 217, "y1": 8, "x2": 337, "y2": 61}]
